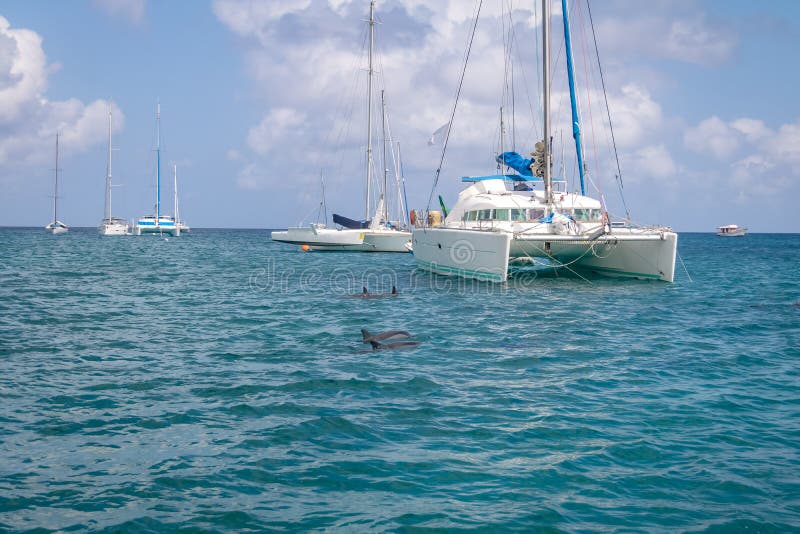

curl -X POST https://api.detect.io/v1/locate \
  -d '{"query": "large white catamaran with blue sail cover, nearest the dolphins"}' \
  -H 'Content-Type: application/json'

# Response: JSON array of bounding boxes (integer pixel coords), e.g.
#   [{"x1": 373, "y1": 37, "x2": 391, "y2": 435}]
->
[{"x1": 413, "y1": 0, "x2": 678, "y2": 282}]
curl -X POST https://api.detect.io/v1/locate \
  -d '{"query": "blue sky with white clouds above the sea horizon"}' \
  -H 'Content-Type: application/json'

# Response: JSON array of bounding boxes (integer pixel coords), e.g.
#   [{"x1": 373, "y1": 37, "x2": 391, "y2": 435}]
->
[{"x1": 0, "y1": 0, "x2": 800, "y2": 232}]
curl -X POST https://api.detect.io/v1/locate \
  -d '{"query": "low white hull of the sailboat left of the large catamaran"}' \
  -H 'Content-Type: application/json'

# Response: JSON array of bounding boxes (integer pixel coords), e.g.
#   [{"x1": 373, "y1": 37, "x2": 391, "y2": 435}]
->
[{"x1": 272, "y1": 227, "x2": 411, "y2": 252}]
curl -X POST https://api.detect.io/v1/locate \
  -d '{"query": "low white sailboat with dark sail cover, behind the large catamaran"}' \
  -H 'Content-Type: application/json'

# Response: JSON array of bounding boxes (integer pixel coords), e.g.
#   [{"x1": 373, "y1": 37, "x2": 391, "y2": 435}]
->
[{"x1": 272, "y1": 0, "x2": 411, "y2": 252}]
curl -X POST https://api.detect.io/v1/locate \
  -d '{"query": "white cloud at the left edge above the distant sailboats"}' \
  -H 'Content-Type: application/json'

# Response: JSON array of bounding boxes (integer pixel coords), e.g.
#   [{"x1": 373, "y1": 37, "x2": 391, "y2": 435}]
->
[{"x1": 0, "y1": 17, "x2": 124, "y2": 174}]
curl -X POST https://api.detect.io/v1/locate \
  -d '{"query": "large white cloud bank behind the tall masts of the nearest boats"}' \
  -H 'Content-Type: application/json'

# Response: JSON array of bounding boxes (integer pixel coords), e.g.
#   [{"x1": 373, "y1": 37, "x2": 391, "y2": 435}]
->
[{"x1": 213, "y1": 0, "x2": 752, "y2": 223}]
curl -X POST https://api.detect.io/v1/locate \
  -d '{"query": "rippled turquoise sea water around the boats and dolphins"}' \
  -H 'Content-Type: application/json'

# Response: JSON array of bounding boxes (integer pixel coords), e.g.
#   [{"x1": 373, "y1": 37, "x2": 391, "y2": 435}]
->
[{"x1": 0, "y1": 229, "x2": 800, "y2": 532}]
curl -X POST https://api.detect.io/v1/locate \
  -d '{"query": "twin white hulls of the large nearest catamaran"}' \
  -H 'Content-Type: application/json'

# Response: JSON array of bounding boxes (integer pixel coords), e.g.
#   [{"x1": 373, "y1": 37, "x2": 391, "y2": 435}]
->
[{"x1": 413, "y1": 228, "x2": 678, "y2": 282}]
